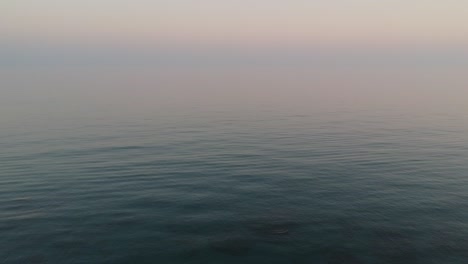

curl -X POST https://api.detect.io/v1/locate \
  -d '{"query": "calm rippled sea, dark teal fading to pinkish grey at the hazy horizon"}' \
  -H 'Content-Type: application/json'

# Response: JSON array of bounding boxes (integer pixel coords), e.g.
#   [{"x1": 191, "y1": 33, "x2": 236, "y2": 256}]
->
[{"x1": 0, "y1": 65, "x2": 468, "y2": 264}]
